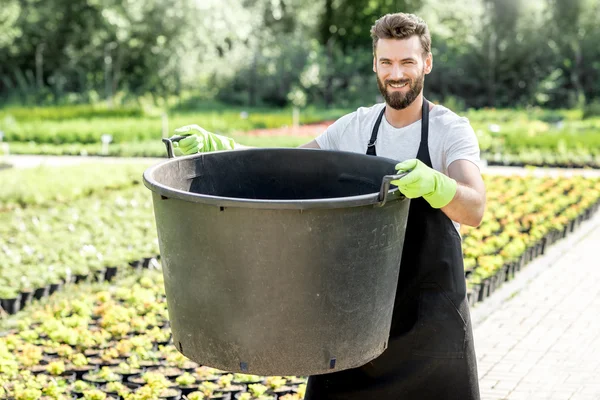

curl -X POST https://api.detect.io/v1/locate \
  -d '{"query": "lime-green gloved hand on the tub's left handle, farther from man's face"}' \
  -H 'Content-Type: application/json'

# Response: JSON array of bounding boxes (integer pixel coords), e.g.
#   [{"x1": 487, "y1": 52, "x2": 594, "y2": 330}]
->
[{"x1": 173, "y1": 125, "x2": 235, "y2": 156}]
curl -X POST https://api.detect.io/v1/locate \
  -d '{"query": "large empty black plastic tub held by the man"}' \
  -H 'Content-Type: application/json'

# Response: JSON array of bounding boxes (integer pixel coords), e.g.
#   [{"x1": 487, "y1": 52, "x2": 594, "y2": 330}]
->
[{"x1": 144, "y1": 149, "x2": 409, "y2": 376}]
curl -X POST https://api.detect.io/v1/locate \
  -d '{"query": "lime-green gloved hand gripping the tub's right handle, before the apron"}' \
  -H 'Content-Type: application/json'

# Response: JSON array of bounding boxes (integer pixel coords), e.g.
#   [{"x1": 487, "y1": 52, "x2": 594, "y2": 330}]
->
[{"x1": 391, "y1": 159, "x2": 458, "y2": 208}]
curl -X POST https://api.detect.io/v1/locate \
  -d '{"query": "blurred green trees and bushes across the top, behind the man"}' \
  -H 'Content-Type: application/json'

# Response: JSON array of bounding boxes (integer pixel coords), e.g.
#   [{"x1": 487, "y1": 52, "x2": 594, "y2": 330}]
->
[{"x1": 0, "y1": 0, "x2": 600, "y2": 111}]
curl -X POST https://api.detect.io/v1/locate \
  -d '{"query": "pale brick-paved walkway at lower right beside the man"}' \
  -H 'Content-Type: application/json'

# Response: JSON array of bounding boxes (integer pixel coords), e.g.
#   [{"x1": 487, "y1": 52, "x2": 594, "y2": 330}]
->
[{"x1": 472, "y1": 213, "x2": 600, "y2": 400}]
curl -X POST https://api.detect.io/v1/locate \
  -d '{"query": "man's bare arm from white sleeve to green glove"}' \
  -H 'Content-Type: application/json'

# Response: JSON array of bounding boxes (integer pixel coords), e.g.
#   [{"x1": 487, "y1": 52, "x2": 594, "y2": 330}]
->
[{"x1": 441, "y1": 160, "x2": 486, "y2": 226}]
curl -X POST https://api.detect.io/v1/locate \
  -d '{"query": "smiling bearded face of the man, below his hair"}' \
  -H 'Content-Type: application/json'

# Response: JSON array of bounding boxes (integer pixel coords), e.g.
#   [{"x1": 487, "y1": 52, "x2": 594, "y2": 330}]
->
[{"x1": 373, "y1": 36, "x2": 432, "y2": 110}]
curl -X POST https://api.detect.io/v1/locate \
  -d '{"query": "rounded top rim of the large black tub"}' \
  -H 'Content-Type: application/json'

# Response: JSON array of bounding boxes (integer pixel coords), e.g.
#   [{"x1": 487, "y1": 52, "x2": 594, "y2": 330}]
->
[{"x1": 143, "y1": 147, "x2": 406, "y2": 210}]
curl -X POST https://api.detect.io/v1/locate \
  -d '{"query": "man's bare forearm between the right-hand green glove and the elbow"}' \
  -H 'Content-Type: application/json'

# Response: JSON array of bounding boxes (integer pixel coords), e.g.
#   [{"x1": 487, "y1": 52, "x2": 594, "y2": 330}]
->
[{"x1": 441, "y1": 183, "x2": 485, "y2": 226}]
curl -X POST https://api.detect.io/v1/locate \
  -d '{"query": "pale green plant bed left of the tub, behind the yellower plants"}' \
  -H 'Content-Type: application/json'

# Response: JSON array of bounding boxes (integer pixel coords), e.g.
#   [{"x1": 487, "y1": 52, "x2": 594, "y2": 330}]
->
[{"x1": 0, "y1": 185, "x2": 159, "y2": 304}]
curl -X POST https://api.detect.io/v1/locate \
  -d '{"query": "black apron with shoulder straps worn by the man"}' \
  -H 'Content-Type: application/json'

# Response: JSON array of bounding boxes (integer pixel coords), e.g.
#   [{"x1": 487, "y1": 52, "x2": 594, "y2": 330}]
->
[{"x1": 305, "y1": 99, "x2": 480, "y2": 400}]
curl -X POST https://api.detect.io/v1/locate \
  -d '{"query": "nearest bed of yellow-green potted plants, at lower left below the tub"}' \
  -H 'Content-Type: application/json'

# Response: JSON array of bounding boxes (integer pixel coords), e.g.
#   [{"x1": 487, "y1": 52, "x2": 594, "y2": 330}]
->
[{"x1": 0, "y1": 270, "x2": 306, "y2": 400}]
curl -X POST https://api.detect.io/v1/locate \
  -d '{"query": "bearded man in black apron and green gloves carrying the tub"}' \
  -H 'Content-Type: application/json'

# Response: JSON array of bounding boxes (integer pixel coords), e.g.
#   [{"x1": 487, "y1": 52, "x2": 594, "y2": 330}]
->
[{"x1": 178, "y1": 13, "x2": 485, "y2": 400}]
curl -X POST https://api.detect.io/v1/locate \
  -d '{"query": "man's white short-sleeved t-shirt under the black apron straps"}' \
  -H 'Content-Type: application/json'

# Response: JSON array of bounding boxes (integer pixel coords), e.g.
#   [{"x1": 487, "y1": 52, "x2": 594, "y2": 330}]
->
[{"x1": 316, "y1": 103, "x2": 480, "y2": 231}]
